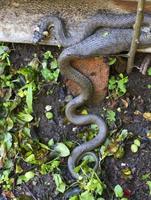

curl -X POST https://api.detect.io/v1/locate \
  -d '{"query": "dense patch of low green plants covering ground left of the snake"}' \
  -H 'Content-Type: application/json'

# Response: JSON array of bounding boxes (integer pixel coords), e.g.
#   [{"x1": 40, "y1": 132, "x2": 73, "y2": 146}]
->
[{"x1": 0, "y1": 45, "x2": 64, "y2": 196}]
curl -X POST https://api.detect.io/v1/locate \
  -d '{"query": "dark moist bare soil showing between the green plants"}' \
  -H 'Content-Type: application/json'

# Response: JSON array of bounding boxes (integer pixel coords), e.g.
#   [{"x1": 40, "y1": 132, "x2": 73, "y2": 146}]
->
[{"x1": 7, "y1": 44, "x2": 151, "y2": 200}]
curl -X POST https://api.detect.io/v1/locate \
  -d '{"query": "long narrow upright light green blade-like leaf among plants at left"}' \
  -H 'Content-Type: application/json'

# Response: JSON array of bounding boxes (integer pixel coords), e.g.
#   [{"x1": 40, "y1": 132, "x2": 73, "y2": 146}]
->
[{"x1": 26, "y1": 83, "x2": 33, "y2": 113}]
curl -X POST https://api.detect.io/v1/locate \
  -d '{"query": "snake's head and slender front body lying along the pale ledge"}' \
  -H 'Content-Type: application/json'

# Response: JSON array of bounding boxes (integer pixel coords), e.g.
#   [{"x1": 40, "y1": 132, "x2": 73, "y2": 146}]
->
[{"x1": 33, "y1": 12, "x2": 151, "y2": 47}]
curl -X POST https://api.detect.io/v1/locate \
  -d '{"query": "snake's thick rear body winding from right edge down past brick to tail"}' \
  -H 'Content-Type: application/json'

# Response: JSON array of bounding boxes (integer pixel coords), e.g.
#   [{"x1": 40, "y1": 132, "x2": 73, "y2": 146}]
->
[{"x1": 58, "y1": 29, "x2": 151, "y2": 179}]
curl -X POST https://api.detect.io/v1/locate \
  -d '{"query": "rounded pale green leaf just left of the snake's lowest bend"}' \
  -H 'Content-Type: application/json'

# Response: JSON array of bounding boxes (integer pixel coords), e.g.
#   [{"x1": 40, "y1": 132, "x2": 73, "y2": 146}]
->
[{"x1": 55, "y1": 143, "x2": 70, "y2": 157}]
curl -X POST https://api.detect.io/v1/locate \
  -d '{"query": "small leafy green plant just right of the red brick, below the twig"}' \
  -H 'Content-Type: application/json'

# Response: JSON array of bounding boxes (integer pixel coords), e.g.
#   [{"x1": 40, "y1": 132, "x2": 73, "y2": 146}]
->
[{"x1": 109, "y1": 74, "x2": 128, "y2": 97}]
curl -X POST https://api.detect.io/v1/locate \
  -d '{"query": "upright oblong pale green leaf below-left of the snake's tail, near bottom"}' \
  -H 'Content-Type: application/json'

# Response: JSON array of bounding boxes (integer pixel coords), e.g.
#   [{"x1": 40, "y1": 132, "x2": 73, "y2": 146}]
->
[{"x1": 53, "y1": 174, "x2": 66, "y2": 193}]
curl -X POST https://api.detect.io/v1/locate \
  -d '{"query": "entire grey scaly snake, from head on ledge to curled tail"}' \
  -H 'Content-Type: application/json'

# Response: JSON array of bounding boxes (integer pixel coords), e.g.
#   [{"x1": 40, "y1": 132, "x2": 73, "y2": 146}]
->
[{"x1": 33, "y1": 13, "x2": 151, "y2": 179}]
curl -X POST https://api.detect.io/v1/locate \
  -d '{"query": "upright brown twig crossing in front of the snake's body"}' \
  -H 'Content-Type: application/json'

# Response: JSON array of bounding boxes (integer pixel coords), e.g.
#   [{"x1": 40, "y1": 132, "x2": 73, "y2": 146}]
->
[{"x1": 126, "y1": 0, "x2": 145, "y2": 74}]
